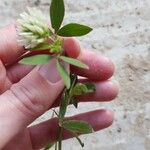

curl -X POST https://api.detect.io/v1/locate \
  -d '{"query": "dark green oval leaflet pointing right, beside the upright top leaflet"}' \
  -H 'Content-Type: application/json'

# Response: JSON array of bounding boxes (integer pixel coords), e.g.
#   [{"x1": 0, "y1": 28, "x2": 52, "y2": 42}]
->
[{"x1": 58, "y1": 23, "x2": 92, "y2": 37}]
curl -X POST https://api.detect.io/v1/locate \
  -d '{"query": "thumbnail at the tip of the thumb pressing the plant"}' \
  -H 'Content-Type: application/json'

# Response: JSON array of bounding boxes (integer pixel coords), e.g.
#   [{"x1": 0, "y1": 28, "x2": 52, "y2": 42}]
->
[{"x1": 38, "y1": 59, "x2": 61, "y2": 83}]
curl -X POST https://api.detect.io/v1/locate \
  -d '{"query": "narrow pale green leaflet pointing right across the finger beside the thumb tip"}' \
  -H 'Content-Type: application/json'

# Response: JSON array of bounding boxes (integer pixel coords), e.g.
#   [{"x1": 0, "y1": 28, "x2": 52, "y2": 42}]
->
[{"x1": 59, "y1": 56, "x2": 89, "y2": 69}]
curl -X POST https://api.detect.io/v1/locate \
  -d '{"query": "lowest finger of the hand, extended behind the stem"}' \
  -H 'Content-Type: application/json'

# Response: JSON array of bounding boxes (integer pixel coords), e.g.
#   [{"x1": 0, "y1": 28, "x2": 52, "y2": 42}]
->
[{"x1": 29, "y1": 110, "x2": 113, "y2": 149}]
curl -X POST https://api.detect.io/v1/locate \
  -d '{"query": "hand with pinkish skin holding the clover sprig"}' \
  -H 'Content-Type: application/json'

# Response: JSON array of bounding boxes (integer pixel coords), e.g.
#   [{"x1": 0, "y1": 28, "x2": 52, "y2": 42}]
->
[{"x1": 0, "y1": 25, "x2": 118, "y2": 150}]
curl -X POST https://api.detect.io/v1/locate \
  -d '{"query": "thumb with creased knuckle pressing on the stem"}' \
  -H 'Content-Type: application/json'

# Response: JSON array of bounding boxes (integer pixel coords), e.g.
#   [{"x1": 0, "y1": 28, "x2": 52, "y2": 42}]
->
[{"x1": 0, "y1": 60, "x2": 67, "y2": 149}]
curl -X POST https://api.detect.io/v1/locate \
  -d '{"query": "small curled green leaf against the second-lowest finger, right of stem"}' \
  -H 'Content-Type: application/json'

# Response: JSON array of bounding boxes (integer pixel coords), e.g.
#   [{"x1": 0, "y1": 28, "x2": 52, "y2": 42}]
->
[{"x1": 72, "y1": 83, "x2": 96, "y2": 96}]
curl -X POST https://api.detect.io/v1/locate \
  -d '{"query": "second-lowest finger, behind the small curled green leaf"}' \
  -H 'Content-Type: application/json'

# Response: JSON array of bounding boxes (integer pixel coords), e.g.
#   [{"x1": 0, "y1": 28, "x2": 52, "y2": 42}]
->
[{"x1": 51, "y1": 80, "x2": 119, "y2": 108}]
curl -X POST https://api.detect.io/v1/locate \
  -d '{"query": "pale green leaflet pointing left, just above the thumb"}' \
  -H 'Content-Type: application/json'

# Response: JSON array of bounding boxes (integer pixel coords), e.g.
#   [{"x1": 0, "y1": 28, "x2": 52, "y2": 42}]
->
[{"x1": 19, "y1": 54, "x2": 53, "y2": 65}]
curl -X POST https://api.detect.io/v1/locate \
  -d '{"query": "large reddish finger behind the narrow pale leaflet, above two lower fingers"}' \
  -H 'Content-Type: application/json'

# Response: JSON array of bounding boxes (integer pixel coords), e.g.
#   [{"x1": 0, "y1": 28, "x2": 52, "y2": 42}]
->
[{"x1": 71, "y1": 50, "x2": 114, "y2": 81}]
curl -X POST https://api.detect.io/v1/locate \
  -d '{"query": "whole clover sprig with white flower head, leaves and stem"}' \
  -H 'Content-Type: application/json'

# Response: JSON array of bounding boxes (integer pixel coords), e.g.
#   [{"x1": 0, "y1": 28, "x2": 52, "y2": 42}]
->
[{"x1": 17, "y1": 0, "x2": 95, "y2": 150}]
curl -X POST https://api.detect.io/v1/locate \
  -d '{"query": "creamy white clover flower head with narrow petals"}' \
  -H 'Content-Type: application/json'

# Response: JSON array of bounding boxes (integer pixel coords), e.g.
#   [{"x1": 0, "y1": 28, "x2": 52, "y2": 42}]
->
[{"x1": 17, "y1": 8, "x2": 52, "y2": 49}]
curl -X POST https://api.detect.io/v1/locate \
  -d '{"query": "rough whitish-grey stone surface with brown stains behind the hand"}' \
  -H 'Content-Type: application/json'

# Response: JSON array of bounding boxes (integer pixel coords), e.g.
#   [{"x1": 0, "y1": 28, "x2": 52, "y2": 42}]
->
[{"x1": 0, "y1": 0, "x2": 150, "y2": 150}]
